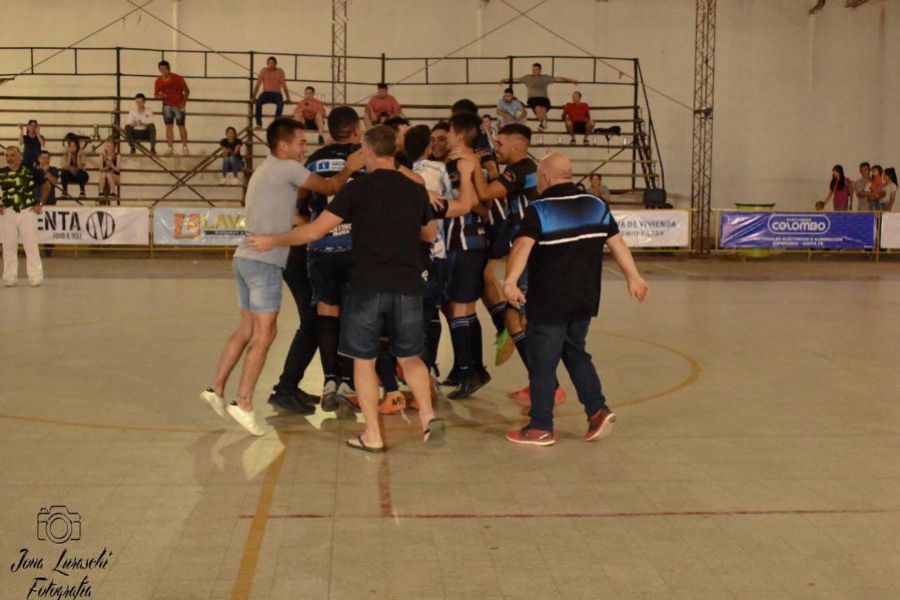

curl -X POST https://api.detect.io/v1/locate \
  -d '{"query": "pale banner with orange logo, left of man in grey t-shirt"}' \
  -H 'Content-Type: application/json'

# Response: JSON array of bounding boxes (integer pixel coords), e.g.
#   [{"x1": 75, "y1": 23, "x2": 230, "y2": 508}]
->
[{"x1": 153, "y1": 207, "x2": 244, "y2": 246}]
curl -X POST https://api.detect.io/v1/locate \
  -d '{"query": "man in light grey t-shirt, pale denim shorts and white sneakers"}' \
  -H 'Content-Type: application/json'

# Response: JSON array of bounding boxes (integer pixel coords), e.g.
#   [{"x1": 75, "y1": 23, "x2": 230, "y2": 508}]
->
[{"x1": 200, "y1": 118, "x2": 363, "y2": 435}]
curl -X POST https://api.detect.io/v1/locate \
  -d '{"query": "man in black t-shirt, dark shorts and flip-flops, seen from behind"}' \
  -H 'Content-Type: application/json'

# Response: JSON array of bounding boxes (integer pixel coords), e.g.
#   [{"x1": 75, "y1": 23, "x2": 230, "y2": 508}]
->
[{"x1": 249, "y1": 125, "x2": 444, "y2": 452}]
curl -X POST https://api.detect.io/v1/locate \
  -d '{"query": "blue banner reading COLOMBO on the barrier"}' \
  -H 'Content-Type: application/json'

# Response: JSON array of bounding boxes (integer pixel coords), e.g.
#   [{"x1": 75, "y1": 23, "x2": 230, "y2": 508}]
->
[{"x1": 719, "y1": 211, "x2": 877, "y2": 250}]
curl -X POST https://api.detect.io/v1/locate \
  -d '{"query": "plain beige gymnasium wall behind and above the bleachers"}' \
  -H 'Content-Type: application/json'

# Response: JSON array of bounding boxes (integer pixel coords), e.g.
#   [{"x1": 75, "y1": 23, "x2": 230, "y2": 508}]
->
[{"x1": 0, "y1": 0, "x2": 900, "y2": 209}]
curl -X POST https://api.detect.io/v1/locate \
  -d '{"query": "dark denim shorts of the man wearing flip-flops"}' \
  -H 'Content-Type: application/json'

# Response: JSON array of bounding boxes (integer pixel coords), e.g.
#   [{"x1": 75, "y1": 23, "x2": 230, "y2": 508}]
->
[{"x1": 338, "y1": 291, "x2": 425, "y2": 360}]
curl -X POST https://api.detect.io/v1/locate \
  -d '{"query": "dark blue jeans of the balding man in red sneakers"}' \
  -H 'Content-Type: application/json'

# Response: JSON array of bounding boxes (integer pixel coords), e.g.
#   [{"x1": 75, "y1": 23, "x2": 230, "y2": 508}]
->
[{"x1": 526, "y1": 319, "x2": 606, "y2": 431}]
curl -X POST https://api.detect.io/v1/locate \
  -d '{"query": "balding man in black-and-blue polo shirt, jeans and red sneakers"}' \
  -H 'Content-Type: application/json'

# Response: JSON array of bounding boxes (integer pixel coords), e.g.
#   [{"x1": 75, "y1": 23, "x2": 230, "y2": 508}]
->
[{"x1": 503, "y1": 154, "x2": 650, "y2": 446}]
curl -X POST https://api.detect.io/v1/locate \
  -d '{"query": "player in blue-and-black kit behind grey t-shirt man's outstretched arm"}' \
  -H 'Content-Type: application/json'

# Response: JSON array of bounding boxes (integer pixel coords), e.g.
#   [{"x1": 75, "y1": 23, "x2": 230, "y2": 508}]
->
[{"x1": 300, "y1": 106, "x2": 360, "y2": 411}]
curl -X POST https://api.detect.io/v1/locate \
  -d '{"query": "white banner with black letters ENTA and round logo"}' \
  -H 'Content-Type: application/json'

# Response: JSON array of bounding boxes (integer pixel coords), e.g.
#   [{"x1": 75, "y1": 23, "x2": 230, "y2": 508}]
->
[{"x1": 38, "y1": 205, "x2": 150, "y2": 246}]
